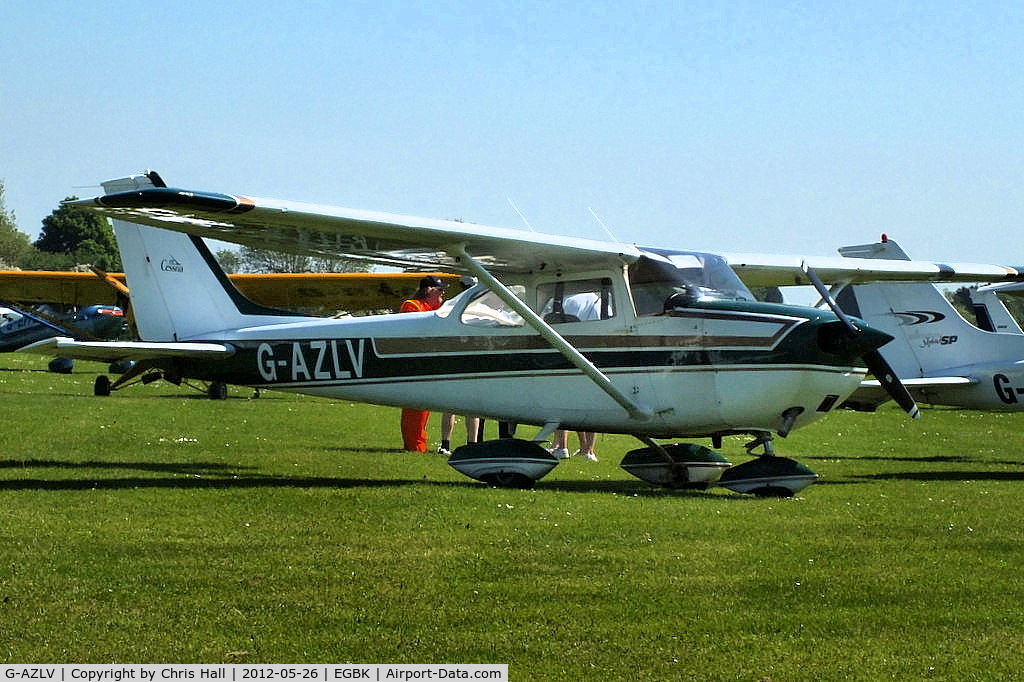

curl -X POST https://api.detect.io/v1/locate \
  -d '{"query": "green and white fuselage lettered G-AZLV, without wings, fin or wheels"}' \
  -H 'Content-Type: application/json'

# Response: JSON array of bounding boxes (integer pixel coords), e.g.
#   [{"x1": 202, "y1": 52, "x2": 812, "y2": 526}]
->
[{"x1": 140, "y1": 254, "x2": 888, "y2": 437}]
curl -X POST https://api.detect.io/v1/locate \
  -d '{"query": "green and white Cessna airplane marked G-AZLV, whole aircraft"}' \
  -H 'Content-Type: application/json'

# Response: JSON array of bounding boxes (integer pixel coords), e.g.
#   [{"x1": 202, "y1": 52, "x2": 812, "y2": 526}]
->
[{"x1": 24, "y1": 172, "x2": 1020, "y2": 495}]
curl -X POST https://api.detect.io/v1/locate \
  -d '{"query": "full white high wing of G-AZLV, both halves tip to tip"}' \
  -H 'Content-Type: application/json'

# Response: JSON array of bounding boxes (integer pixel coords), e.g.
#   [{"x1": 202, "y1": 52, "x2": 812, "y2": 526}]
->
[{"x1": 71, "y1": 172, "x2": 1024, "y2": 286}]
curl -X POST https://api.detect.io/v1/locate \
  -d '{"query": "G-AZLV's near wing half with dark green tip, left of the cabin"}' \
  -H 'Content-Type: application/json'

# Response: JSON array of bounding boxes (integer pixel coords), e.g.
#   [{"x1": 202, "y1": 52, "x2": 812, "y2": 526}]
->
[{"x1": 72, "y1": 173, "x2": 641, "y2": 273}]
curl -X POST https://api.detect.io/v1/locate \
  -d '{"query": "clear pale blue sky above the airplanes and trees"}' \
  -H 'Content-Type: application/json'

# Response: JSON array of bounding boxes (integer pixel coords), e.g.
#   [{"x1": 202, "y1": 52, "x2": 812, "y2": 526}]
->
[{"x1": 0, "y1": 0, "x2": 1024, "y2": 264}]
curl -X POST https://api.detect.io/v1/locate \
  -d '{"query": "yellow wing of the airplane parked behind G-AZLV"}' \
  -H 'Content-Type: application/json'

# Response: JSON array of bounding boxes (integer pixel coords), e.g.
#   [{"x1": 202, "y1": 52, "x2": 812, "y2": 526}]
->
[{"x1": 0, "y1": 270, "x2": 456, "y2": 310}]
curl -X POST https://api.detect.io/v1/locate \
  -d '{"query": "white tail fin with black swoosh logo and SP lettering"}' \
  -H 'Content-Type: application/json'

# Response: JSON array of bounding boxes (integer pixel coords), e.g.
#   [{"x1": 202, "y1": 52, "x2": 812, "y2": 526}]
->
[{"x1": 838, "y1": 236, "x2": 1006, "y2": 379}]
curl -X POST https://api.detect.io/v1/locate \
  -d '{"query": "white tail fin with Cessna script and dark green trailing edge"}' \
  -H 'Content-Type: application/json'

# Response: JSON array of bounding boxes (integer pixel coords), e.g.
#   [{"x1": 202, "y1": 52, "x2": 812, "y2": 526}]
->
[{"x1": 103, "y1": 173, "x2": 301, "y2": 342}]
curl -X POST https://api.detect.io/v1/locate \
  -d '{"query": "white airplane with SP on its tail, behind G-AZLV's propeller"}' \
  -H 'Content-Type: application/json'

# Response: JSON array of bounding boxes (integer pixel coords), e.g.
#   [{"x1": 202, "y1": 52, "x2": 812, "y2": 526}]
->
[{"x1": 837, "y1": 237, "x2": 1024, "y2": 411}]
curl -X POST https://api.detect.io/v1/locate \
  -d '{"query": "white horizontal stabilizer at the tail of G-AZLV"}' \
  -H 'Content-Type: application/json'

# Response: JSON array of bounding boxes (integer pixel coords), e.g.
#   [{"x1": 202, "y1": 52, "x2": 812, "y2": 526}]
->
[{"x1": 18, "y1": 336, "x2": 234, "y2": 363}]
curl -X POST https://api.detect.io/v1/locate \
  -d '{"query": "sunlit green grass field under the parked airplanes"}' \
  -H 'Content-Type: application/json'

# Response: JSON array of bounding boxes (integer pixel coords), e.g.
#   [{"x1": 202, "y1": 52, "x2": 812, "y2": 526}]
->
[{"x1": 0, "y1": 354, "x2": 1024, "y2": 681}]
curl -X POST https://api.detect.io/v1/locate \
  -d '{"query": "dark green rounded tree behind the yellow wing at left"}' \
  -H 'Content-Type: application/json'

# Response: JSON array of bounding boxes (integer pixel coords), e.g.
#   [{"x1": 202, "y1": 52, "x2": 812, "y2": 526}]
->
[{"x1": 35, "y1": 197, "x2": 121, "y2": 270}]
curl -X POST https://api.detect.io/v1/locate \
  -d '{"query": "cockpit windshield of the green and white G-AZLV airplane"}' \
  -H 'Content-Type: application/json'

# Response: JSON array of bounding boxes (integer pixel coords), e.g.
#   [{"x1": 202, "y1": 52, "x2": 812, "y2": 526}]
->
[{"x1": 629, "y1": 251, "x2": 755, "y2": 315}]
